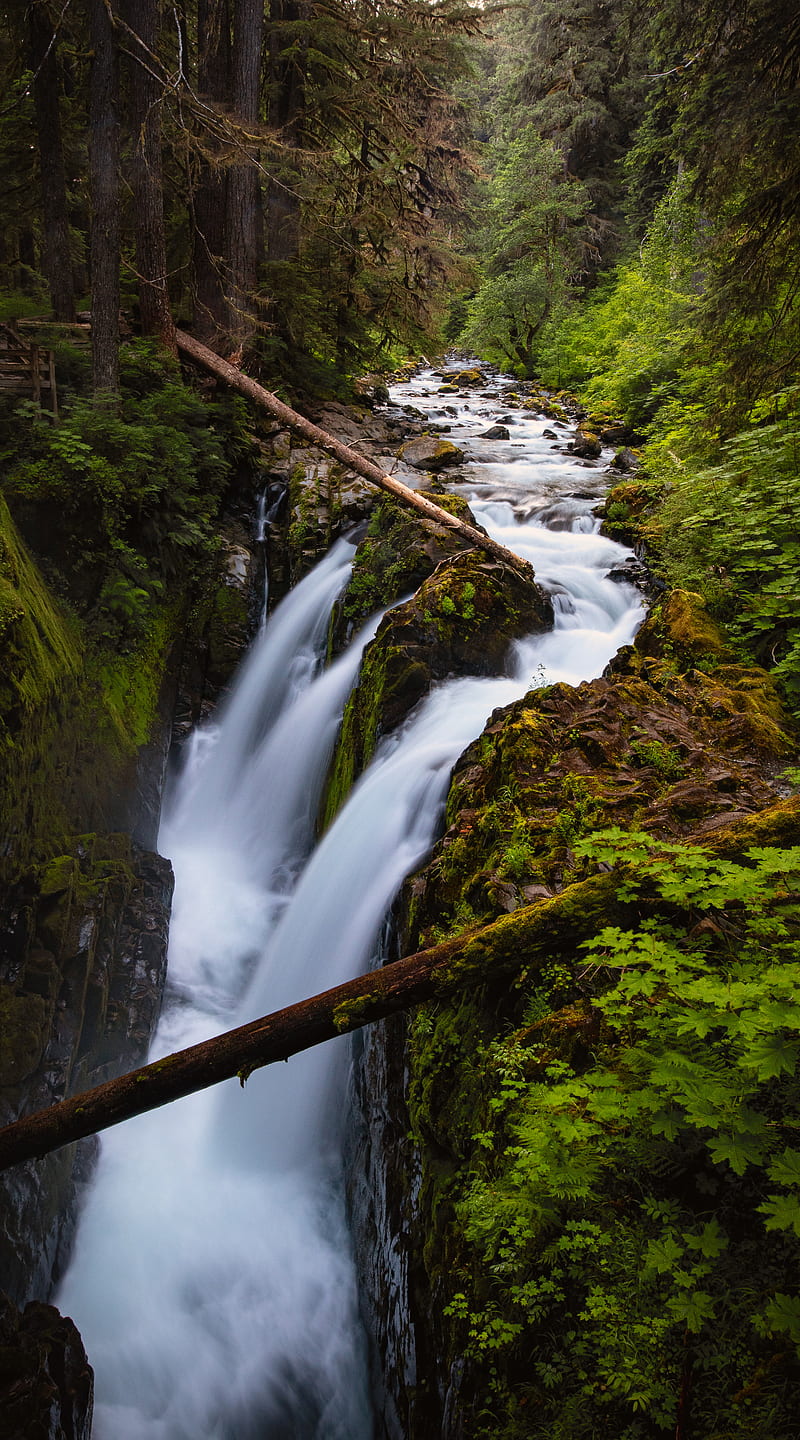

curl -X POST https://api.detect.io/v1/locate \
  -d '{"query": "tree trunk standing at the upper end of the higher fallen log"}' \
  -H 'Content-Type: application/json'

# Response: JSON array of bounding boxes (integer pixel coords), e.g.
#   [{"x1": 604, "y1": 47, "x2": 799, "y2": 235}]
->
[{"x1": 122, "y1": 0, "x2": 177, "y2": 354}]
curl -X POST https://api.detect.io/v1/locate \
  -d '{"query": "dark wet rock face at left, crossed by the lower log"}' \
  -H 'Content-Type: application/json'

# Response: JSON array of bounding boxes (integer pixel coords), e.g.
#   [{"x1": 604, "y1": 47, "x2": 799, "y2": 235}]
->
[{"x1": 0, "y1": 835, "x2": 173, "y2": 1303}]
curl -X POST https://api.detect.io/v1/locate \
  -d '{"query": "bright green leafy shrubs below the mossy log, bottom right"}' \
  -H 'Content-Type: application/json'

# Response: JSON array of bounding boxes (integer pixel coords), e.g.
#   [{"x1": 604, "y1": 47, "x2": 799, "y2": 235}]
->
[{"x1": 447, "y1": 829, "x2": 800, "y2": 1440}]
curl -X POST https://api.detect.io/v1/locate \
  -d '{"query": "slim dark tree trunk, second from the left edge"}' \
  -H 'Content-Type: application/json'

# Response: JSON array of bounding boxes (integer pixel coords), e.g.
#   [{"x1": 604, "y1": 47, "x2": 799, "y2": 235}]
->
[{"x1": 89, "y1": 0, "x2": 119, "y2": 395}]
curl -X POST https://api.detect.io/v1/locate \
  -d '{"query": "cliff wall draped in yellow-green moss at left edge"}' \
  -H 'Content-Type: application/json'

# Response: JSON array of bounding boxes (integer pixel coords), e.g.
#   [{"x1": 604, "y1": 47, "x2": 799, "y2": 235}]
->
[{"x1": 0, "y1": 500, "x2": 184, "y2": 884}]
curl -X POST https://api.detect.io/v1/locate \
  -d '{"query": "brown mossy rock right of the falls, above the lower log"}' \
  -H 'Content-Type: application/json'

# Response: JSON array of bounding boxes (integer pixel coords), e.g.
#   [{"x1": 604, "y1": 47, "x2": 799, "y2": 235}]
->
[{"x1": 412, "y1": 593, "x2": 797, "y2": 945}]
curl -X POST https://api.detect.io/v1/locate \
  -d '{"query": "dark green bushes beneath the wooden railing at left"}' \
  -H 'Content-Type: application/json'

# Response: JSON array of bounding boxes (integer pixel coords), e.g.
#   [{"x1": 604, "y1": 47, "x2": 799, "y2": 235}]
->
[{"x1": 4, "y1": 344, "x2": 237, "y2": 641}]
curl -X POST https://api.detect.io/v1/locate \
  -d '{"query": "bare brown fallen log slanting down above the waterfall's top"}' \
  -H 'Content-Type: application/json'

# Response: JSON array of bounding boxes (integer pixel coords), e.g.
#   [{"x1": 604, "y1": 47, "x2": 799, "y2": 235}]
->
[{"x1": 176, "y1": 330, "x2": 532, "y2": 577}]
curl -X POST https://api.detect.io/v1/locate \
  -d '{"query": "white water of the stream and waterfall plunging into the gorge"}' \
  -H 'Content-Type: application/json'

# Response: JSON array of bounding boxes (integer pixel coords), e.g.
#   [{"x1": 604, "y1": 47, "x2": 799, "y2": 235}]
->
[{"x1": 59, "y1": 362, "x2": 642, "y2": 1440}]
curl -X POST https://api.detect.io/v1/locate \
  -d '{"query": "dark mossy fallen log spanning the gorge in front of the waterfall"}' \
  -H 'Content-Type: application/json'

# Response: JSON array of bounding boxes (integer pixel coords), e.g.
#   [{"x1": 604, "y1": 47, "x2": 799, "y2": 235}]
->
[{"x1": 0, "y1": 874, "x2": 623, "y2": 1171}]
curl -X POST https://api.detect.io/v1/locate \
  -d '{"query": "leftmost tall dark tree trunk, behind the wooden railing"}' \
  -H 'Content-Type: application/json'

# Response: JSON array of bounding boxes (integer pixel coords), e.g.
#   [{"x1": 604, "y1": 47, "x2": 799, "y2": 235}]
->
[{"x1": 27, "y1": 0, "x2": 75, "y2": 323}]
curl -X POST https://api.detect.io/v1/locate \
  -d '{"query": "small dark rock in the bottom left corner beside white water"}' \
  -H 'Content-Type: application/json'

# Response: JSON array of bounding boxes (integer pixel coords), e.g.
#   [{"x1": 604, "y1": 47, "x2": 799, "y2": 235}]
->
[{"x1": 0, "y1": 1293, "x2": 94, "y2": 1440}]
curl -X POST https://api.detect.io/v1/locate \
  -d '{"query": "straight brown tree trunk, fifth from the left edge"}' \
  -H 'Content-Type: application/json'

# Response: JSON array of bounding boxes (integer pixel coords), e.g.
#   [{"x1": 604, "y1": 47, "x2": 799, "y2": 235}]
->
[{"x1": 227, "y1": 0, "x2": 263, "y2": 350}]
